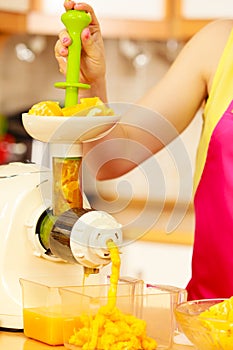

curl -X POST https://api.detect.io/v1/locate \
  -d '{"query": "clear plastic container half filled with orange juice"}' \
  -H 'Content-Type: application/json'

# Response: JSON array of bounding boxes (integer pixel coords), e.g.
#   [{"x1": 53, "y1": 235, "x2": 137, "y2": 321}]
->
[{"x1": 20, "y1": 278, "x2": 143, "y2": 345}]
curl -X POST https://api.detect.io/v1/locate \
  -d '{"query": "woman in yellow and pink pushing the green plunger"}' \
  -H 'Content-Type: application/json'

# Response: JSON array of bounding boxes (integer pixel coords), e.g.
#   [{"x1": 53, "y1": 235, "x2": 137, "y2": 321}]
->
[{"x1": 55, "y1": 1, "x2": 233, "y2": 299}]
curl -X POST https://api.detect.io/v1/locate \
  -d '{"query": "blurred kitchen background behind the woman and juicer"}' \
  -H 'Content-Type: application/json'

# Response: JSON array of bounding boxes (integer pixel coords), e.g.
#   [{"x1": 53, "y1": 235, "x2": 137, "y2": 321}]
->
[{"x1": 0, "y1": 0, "x2": 233, "y2": 285}]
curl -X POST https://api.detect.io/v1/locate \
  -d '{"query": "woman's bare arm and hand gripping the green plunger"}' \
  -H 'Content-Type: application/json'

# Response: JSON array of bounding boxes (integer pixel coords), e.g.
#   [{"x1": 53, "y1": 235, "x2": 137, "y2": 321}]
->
[{"x1": 57, "y1": 4, "x2": 232, "y2": 180}]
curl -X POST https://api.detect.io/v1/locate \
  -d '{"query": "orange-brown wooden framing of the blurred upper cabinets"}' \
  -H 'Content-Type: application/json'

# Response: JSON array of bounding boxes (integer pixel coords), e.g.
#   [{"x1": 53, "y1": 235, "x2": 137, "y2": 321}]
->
[{"x1": 0, "y1": 0, "x2": 212, "y2": 41}]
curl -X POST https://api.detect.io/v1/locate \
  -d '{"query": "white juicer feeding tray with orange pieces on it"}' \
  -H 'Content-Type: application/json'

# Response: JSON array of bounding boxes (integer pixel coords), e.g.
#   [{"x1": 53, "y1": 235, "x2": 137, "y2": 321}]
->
[{"x1": 22, "y1": 97, "x2": 120, "y2": 143}]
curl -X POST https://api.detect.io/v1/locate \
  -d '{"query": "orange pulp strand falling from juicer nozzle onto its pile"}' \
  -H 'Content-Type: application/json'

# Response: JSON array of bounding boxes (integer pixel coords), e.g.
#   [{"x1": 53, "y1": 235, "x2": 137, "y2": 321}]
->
[{"x1": 66, "y1": 241, "x2": 157, "y2": 350}]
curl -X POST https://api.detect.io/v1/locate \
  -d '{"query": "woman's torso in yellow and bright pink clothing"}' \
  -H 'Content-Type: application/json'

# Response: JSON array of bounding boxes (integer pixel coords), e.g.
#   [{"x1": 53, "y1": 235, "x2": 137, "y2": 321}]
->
[{"x1": 187, "y1": 23, "x2": 233, "y2": 299}]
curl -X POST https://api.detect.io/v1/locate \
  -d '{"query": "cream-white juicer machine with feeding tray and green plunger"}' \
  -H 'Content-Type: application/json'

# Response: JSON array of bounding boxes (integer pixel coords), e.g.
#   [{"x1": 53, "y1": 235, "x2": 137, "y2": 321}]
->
[{"x1": 0, "y1": 10, "x2": 122, "y2": 330}]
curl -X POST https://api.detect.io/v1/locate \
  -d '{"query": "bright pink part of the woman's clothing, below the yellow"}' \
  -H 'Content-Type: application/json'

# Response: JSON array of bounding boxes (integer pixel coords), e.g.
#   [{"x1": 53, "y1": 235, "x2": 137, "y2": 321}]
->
[{"x1": 187, "y1": 101, "x2": 233, "y2": 299}]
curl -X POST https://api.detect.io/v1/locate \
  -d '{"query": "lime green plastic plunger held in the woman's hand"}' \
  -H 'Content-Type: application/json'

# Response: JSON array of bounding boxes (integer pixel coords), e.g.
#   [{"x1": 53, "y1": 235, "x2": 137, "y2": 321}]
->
[{"x1": 54, "y1": 9, "x2": 91, "y2": 107}]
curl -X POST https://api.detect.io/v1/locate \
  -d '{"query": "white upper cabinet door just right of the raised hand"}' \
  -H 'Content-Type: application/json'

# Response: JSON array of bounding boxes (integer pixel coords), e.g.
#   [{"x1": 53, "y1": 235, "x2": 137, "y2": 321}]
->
[{"x1": 86, "y1": 0, "x2": 173, "y2": 40}]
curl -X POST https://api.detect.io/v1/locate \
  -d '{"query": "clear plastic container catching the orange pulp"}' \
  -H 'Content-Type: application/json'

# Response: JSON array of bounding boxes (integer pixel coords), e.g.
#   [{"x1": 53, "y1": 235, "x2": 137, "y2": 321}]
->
[{"x1": 60, "y1": 280, "x2": 186, "y2": 350}]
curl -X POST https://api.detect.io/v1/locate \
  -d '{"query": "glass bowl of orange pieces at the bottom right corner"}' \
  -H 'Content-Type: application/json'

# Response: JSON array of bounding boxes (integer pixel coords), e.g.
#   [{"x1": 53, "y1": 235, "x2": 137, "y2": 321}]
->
[{"x1": 175, "y1": 297, "x2": 233, "y2": 350}]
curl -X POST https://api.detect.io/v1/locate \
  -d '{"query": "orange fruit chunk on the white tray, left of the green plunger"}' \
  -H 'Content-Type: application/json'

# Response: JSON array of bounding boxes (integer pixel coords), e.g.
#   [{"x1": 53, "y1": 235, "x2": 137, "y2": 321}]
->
[{"x1": 28, "y1": 101, "x2": 63, "y2": 116}]
